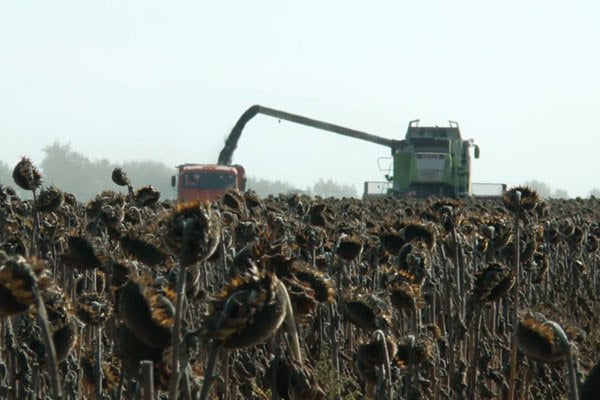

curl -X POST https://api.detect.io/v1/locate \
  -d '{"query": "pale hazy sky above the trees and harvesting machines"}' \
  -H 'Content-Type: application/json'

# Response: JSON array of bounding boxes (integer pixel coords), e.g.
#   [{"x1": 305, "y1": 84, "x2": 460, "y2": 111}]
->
[{"x1": 0, "y1": 0, "x2": 600, "y2": 196}]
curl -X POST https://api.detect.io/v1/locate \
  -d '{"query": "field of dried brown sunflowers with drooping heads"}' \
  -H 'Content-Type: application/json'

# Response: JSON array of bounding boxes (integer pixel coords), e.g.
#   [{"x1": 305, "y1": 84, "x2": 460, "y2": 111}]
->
[{"x1": 0, "y1": 159, "x2": 600, "y2": 400}]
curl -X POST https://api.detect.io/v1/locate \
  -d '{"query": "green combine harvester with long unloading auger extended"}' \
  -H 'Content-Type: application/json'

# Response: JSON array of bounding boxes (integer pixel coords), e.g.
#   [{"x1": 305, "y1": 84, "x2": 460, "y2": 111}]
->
[{"x1": 218, "y1": 105, "x2": 504, "y2": 197}]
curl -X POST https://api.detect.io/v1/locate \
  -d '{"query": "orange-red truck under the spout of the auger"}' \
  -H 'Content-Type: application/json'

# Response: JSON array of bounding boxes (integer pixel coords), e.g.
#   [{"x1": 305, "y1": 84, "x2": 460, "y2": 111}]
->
[{"x1": 171, "y1": 164, "x2": 246, "y2": 202}]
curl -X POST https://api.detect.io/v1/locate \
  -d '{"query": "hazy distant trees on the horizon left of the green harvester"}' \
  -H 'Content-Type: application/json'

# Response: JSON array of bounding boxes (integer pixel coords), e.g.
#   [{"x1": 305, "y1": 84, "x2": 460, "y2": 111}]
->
[{"x1": 0, "y1": 142, "x2": 357, "y2": 201}]
